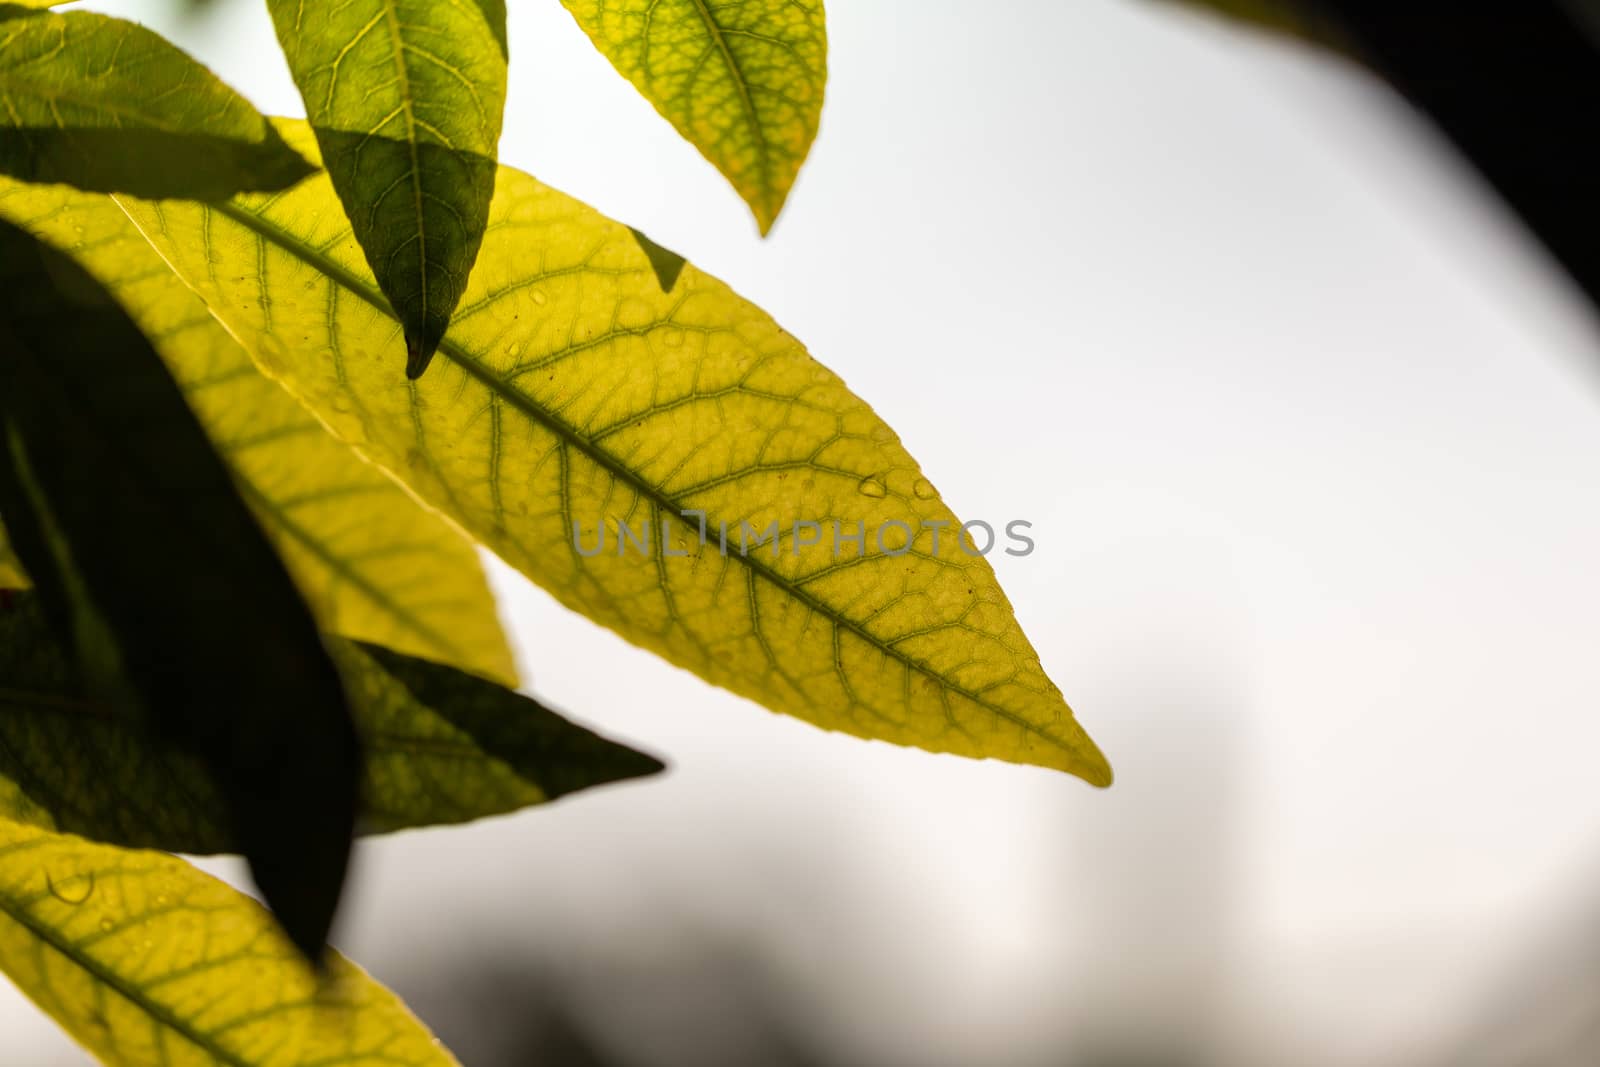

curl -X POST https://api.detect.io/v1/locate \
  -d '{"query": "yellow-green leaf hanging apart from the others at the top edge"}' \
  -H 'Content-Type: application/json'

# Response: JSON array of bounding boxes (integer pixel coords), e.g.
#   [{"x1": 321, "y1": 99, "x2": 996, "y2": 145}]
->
[{"x1": 562, "y1": 0, "x2": 827, "y2": 234}]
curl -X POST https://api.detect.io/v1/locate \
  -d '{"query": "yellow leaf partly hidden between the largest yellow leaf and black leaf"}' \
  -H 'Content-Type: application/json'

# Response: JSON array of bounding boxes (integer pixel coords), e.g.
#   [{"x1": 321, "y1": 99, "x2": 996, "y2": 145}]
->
[{"x1": 0, "y1": 179, "x2": 517, "y2": 685}]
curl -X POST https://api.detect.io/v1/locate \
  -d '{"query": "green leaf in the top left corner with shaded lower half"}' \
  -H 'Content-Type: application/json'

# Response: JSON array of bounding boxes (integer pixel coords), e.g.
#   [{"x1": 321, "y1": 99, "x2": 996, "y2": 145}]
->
[{"x1": 0, "y1": 3, "x2": 312, "y2": 200}]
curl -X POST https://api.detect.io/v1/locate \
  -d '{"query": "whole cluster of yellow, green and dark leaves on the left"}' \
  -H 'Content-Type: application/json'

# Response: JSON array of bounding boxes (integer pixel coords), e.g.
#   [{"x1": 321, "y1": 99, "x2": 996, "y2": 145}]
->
[{"x1": 0, "y1": 0, "x2": 1110, "y2": 1065}]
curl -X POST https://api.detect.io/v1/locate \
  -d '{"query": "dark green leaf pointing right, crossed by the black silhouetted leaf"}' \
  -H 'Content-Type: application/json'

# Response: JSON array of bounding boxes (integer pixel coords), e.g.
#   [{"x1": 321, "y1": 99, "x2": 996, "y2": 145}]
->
[{"x1": 0, "y1": 593, "x2": 661, "y2": 854}]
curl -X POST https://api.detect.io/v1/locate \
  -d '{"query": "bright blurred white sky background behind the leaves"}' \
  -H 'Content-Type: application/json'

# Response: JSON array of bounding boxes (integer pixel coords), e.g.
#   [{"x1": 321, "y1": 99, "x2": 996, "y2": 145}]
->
[{"x1": 0, "y1": 0, "x2": 1600, "y2": 1067}]
